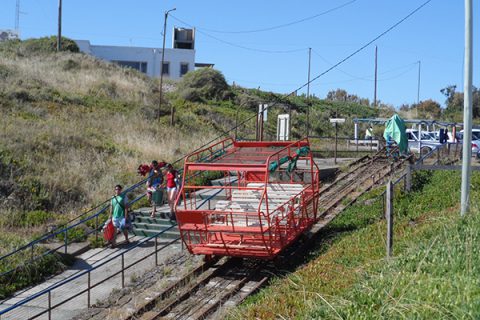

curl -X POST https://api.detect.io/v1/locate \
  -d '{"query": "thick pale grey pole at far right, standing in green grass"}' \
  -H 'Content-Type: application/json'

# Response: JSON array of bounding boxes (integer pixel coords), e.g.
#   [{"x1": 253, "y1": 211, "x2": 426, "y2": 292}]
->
[{"x1": 460, "y1": 0, "x2": 473, "y2": 216}]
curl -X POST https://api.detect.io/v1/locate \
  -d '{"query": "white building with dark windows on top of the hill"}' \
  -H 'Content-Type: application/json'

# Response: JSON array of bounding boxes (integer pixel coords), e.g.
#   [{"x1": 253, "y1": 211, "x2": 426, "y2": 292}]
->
[{"x1": 75, "y1": 28, "x2": 204, "y2": 80}]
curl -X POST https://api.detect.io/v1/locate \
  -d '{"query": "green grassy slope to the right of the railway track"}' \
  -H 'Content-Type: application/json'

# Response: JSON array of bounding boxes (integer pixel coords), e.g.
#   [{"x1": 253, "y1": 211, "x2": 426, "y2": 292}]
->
[{"x1": 229, "y1": 172, "x2": 480, "y2": 319}]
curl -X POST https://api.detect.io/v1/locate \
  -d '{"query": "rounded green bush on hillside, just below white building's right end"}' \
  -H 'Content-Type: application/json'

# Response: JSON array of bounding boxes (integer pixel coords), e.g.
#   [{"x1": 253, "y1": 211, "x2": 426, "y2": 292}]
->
[{"x1": 177, "y1": 68, "x2": 229, "y2": 101}]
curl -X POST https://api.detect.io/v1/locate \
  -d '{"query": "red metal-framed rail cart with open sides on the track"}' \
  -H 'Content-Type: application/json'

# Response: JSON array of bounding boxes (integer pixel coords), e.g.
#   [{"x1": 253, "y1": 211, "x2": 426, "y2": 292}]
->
[{"x1": 176, "y1": 138, "x2": 320, "y2": 259}]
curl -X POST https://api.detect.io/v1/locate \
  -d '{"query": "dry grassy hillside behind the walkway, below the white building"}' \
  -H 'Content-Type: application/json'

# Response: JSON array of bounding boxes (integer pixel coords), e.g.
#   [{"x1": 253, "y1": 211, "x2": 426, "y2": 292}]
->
[{"x1": 0, "y1": 39, "x2": 438, "y2": 302}]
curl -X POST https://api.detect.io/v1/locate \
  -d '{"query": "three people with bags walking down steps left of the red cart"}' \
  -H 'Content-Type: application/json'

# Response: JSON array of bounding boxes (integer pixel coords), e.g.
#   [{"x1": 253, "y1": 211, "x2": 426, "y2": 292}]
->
[{"x1": 109, "y1": 160, "x2": 180, "y2": 247}]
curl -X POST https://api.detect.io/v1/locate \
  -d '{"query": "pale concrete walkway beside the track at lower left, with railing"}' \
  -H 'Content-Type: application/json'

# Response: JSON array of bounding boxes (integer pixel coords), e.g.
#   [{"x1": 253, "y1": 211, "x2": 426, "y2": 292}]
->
[{"x1": 0, "y1": 226, "x2": 180, "y2": 320}]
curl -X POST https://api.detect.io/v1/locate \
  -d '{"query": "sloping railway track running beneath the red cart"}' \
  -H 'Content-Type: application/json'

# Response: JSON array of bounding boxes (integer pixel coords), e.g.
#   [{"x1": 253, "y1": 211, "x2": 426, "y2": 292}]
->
[{"x1": 111, "y1": 155, "x2": 403, "y2": 320}]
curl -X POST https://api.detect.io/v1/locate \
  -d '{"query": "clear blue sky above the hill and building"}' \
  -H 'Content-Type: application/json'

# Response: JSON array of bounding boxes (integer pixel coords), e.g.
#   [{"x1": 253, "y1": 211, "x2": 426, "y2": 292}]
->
[{"x1": 0, "y1": 0, "x2": 480, "y2": 107}]
